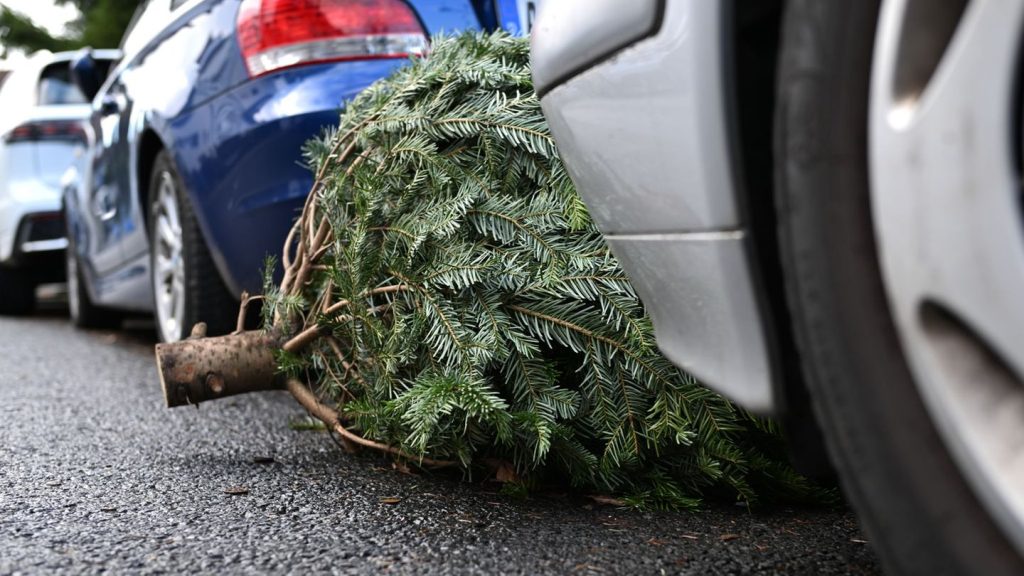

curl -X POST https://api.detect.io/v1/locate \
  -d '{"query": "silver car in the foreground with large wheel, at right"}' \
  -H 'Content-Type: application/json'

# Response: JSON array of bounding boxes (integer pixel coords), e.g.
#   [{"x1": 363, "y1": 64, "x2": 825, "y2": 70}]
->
[{"x1": 532, "y1": 0, "x2": 1024, "y2": 575}]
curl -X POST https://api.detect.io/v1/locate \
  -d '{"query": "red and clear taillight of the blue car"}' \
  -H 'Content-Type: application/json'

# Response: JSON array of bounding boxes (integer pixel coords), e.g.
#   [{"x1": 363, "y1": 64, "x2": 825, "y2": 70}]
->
[{"x1": 238, "y1": 0, "x2": 427, "y2": 77}]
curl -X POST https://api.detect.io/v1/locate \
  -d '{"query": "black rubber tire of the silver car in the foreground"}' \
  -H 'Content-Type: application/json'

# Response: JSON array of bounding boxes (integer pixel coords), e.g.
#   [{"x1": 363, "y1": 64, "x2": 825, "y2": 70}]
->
[{"x1": 775, "y1": 0, "x2": 1024, "y2": 575}]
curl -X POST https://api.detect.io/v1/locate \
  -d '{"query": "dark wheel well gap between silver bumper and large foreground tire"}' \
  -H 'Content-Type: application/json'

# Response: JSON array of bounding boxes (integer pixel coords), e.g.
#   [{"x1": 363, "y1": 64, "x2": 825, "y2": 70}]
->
[{"x1": 729, "y1": 0, "x2": 834, "y2": 478}]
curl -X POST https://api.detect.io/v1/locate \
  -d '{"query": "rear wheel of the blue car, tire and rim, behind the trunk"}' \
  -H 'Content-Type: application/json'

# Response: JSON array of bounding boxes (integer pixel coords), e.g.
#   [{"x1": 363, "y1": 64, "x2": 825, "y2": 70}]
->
[{"x1": 150, "y1": 152, "x2": 238, "y2": 342}]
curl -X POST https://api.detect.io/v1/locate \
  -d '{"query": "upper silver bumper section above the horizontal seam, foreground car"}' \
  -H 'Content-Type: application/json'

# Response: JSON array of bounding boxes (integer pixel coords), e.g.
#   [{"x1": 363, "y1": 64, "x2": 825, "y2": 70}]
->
[{"x1": 534, "y1": 1, "x2": 739, "y2": 234}]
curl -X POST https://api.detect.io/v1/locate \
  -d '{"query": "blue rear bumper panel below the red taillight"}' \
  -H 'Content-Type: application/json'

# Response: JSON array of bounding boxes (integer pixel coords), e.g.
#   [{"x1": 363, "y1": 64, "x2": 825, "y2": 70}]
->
[{"x1": 168, "y1": 59, "x2": 403, "y2": 293}]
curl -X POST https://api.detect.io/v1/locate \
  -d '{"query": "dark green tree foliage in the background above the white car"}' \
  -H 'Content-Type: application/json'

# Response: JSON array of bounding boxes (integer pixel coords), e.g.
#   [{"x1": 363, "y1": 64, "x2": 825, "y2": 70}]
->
[{"x1": 0, "y1": 0, "x2": 141, "y2": 56}]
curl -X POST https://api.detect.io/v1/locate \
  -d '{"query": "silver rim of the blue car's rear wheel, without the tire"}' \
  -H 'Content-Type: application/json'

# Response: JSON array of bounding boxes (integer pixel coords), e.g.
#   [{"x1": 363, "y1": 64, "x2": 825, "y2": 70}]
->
[{"x1": 153, "y1": 172, "x2": 185, "y2": 342}]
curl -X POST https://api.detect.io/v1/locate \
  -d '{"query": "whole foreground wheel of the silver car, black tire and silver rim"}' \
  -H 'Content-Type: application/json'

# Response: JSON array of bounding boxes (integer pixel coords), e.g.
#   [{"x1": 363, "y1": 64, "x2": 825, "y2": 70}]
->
[{"x1": 775, "y1": 0, "x2": 1024, "y2": 575}]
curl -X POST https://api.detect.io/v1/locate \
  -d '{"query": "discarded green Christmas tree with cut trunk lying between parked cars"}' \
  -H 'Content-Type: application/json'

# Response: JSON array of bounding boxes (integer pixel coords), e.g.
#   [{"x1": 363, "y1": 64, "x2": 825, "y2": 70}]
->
[{"x1": 157, "y1": 34, "x2": 815, "y2": 506}]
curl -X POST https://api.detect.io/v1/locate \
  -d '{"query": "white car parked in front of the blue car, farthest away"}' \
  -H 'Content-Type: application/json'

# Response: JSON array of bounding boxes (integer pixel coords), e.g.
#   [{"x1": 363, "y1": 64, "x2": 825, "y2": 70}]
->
[{"x1": 0, "y1": 50, "x2": 118, "y2": 314}]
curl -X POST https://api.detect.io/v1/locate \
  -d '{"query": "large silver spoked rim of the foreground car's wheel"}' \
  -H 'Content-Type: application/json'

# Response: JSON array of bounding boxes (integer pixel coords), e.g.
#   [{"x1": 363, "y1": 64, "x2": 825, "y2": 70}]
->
[{"x1": 868, "y1": 0, "x2": 1024, "y2": 553}]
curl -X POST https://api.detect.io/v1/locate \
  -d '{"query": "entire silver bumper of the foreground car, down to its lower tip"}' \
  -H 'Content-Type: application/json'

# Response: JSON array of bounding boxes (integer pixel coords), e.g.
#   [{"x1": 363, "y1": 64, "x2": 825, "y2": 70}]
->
[{"x1": 532, "y1": 0, "x2": 778, "y2": 413}]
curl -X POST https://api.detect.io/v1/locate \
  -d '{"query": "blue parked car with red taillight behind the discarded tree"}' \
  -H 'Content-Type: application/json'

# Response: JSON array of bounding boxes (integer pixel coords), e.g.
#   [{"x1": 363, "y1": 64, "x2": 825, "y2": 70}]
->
[{"x1": 63, "y1": 0, "x2": 534, "y2": 341}]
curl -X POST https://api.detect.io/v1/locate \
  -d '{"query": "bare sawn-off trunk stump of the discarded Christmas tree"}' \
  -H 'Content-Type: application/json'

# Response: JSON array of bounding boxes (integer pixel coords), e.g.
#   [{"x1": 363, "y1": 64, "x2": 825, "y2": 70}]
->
[{"x1": 157, "y1": 331, "x2": 285, "y2": 408}]
